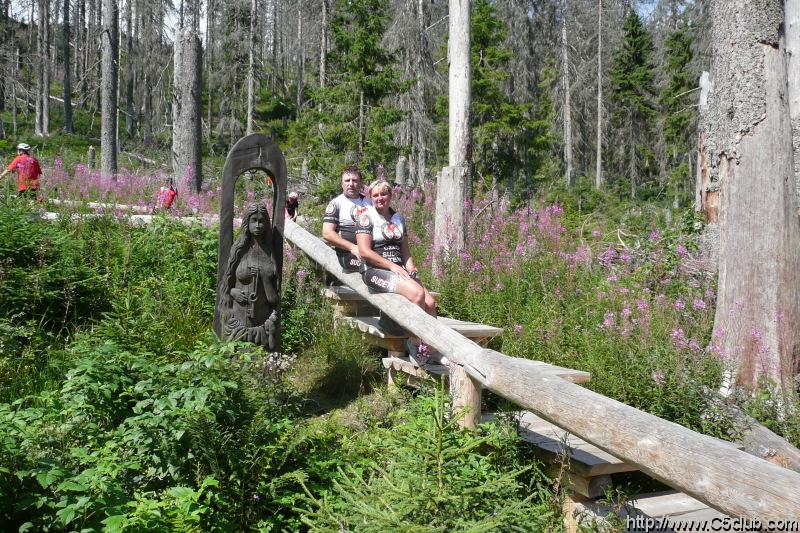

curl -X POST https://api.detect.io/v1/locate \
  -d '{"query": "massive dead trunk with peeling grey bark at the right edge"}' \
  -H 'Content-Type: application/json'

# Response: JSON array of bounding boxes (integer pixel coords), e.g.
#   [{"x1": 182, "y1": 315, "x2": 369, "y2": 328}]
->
[{"x1": 706, "y1": 0, "x2": 800, "y2": 394}]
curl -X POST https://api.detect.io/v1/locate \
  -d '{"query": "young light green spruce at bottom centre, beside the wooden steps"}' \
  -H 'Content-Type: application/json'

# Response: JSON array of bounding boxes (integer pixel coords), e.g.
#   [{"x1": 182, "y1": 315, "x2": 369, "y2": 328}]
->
[{"x1": 303, "y1": 388, "x2": 560, "y2": 532}]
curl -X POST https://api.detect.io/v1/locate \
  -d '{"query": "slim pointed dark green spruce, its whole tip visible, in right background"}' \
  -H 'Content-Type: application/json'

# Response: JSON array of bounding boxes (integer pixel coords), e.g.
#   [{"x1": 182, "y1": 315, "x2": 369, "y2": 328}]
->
[{"x1": 610, "y1": 10, "x2": 656, "y2": 197}]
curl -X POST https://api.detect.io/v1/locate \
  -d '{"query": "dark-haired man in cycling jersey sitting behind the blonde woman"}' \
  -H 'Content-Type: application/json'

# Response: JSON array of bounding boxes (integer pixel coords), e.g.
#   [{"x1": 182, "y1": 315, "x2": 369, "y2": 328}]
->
[{"x1": 322, "y1": 166, "x2": 372, "y2": 272}]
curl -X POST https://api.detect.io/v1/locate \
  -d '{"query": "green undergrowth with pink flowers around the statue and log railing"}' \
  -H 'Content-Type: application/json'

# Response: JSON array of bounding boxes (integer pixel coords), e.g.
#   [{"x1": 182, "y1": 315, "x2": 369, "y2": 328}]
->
[{"x1": 0, "y1": 169, "x2": 800, "y2": 531}]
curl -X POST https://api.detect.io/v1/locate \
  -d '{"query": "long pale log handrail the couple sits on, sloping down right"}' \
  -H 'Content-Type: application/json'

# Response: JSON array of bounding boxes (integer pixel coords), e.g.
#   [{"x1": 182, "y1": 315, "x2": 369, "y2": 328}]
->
[{"x1": 284, "y1": 220, "x2": 800, "y2": 527}]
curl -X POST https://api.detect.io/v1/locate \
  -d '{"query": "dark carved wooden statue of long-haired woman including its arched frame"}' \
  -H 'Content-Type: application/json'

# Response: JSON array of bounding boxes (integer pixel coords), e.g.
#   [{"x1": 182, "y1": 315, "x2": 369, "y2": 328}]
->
[{"x1": 214, "y1": 134, "x2": 286, "y2": 351}]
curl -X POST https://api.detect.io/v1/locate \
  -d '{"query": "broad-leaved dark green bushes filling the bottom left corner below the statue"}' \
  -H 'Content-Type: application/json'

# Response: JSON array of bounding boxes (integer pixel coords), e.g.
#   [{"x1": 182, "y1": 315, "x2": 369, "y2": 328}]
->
[{"x1": 0, "y1": 343, "x2": 333, "y2": 531}]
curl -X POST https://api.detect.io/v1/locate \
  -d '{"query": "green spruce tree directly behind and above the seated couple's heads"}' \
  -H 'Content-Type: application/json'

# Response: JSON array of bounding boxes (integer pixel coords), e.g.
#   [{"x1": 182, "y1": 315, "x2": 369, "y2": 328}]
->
[{"x1": 288, "y1": 0, "x2": 409, "y2": 189}]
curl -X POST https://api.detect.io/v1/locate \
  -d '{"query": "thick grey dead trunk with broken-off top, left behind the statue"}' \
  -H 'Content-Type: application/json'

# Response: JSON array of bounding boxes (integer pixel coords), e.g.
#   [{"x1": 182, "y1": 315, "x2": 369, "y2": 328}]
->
[{"x1": 172, "y1": 29, "x2": 203, "y2": 192}]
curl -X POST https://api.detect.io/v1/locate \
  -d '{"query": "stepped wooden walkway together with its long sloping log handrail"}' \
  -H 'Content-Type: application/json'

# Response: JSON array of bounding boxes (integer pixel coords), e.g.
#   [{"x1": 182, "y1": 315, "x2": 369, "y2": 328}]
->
[{"x1": 283, "y1": 220, "x2": 800, "y2": 531}]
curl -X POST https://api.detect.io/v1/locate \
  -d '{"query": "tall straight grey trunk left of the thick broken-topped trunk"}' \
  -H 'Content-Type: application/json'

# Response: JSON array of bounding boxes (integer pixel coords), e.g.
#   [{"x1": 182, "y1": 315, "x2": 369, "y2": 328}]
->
[{"x1": 100, "y1": 0, "x2": 119, "y2": 176}]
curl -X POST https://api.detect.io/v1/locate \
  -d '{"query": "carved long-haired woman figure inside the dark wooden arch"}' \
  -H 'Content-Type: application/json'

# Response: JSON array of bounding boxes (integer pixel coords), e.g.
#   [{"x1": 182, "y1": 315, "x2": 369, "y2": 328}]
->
[{"x1": 220, "y1": 202, "x2": 279, "y2": 350}]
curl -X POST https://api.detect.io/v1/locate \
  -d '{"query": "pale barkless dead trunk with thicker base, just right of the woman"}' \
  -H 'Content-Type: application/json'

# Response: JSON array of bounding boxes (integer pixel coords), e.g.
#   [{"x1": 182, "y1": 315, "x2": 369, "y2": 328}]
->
[{"x1": 434, "y1": 0, "x2": 472, "y2": 255}]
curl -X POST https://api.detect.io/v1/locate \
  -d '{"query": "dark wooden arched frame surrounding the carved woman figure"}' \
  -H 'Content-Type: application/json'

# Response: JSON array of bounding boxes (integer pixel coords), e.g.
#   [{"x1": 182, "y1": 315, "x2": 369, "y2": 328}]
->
[{"x1": 214, "y1": 133, "x2": 286, "y2": 350}]
